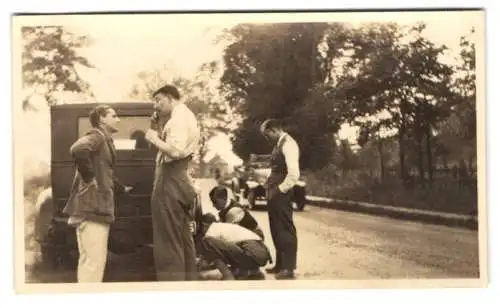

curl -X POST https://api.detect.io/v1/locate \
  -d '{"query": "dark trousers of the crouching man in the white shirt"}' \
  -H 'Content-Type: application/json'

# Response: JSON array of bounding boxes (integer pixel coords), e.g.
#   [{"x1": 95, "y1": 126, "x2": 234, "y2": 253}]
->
[{"x1": 198, "y1": 237, "x2": 270, "y2": 270}]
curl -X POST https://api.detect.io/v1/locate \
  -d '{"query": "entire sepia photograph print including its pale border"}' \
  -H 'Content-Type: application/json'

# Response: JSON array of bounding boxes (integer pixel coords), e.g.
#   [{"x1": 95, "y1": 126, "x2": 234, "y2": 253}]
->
[{"x1": 11, "y1": 9, "x2": 488, "y2": 293}]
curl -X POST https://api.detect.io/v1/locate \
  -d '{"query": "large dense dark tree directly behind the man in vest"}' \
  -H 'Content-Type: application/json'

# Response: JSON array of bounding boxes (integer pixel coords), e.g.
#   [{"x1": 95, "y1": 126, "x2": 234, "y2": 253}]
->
[{"x1": 221, "y1": 23, "x2": 349, "y2": 169}]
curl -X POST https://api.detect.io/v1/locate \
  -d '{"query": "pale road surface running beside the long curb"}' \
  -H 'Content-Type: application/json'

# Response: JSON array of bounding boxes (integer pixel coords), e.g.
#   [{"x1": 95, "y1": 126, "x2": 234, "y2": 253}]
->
[{"x1": 25, "y1": 180, "x2": 479, "y2": 282}]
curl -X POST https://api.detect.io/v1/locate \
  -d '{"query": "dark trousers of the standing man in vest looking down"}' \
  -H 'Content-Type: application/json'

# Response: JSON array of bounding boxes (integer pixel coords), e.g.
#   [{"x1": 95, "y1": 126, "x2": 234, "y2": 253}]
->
[{"x1": 267, "y1": 190, "x2": 297, "y2": 270}]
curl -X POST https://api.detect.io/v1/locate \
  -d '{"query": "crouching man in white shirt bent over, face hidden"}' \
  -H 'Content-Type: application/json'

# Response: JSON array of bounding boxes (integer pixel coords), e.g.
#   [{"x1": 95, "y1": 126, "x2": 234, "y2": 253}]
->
[{"x1": 197, "y1": 213, "x2": 271, "y2": 280}]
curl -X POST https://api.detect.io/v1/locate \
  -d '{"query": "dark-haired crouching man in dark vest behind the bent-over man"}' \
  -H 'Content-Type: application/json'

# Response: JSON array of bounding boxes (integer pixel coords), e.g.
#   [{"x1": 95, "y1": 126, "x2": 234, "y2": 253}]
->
[{"x1": 209, "y1": 186, "x2": 264, "y2": 240}]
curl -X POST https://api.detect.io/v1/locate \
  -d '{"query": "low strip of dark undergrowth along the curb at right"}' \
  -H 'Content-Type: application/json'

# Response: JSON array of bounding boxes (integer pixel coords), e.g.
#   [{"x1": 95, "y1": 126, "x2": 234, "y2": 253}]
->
[{"x1": 303, "y1": 165, "x2": 477, "y2": 214}]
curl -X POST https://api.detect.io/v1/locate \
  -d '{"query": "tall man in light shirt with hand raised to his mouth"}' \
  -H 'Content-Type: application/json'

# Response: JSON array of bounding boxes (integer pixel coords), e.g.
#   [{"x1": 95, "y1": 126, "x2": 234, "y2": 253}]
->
[{"x1": 146, "y1": 85, "x2": 200, "y2": 281}]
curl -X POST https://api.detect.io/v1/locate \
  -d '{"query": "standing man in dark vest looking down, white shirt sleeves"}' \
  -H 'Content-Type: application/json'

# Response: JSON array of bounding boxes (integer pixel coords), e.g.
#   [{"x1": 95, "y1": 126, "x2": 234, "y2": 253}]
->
[{"x1": 260, "y1": 120, "x2": 300, "y2": 279}]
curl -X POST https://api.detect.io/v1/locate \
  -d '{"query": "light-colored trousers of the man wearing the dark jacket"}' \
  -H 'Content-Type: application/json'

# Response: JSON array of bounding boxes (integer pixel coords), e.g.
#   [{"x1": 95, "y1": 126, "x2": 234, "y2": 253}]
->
[{"x1": 76, "y1": 220, "x2": 110, "y2": 282}]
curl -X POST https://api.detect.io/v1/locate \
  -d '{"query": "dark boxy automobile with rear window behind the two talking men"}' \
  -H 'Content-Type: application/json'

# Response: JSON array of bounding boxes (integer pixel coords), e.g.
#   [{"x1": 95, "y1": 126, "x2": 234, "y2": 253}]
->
[{"x1": 35, "y1": 102, "x2": 201, "y2": 276}]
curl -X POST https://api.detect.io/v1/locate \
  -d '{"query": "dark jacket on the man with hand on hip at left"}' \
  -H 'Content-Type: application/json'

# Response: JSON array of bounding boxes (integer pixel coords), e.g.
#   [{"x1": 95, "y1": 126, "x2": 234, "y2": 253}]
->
[{"x1": 63, "y1": 129, "x2": 124, "y2": 223}]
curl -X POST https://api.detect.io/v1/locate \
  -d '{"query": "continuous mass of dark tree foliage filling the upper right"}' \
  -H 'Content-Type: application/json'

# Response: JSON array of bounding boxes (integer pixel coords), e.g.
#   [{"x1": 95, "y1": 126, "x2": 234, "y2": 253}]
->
[{"x1": 221, "y1": 23, "x2": 475, "y2": 181}]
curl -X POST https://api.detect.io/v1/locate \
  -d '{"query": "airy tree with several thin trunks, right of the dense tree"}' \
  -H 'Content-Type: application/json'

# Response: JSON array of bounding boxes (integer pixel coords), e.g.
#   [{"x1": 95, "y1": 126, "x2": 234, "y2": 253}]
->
[{"x1": 340, "y1": 24, "x2": 453, "y2": 180}]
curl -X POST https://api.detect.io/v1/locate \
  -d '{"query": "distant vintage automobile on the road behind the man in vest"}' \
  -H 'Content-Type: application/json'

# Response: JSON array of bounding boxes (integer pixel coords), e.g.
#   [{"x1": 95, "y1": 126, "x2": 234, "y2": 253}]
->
[{"x1": 231, "y1": 154, "x2": 306, "y2": 211}]
